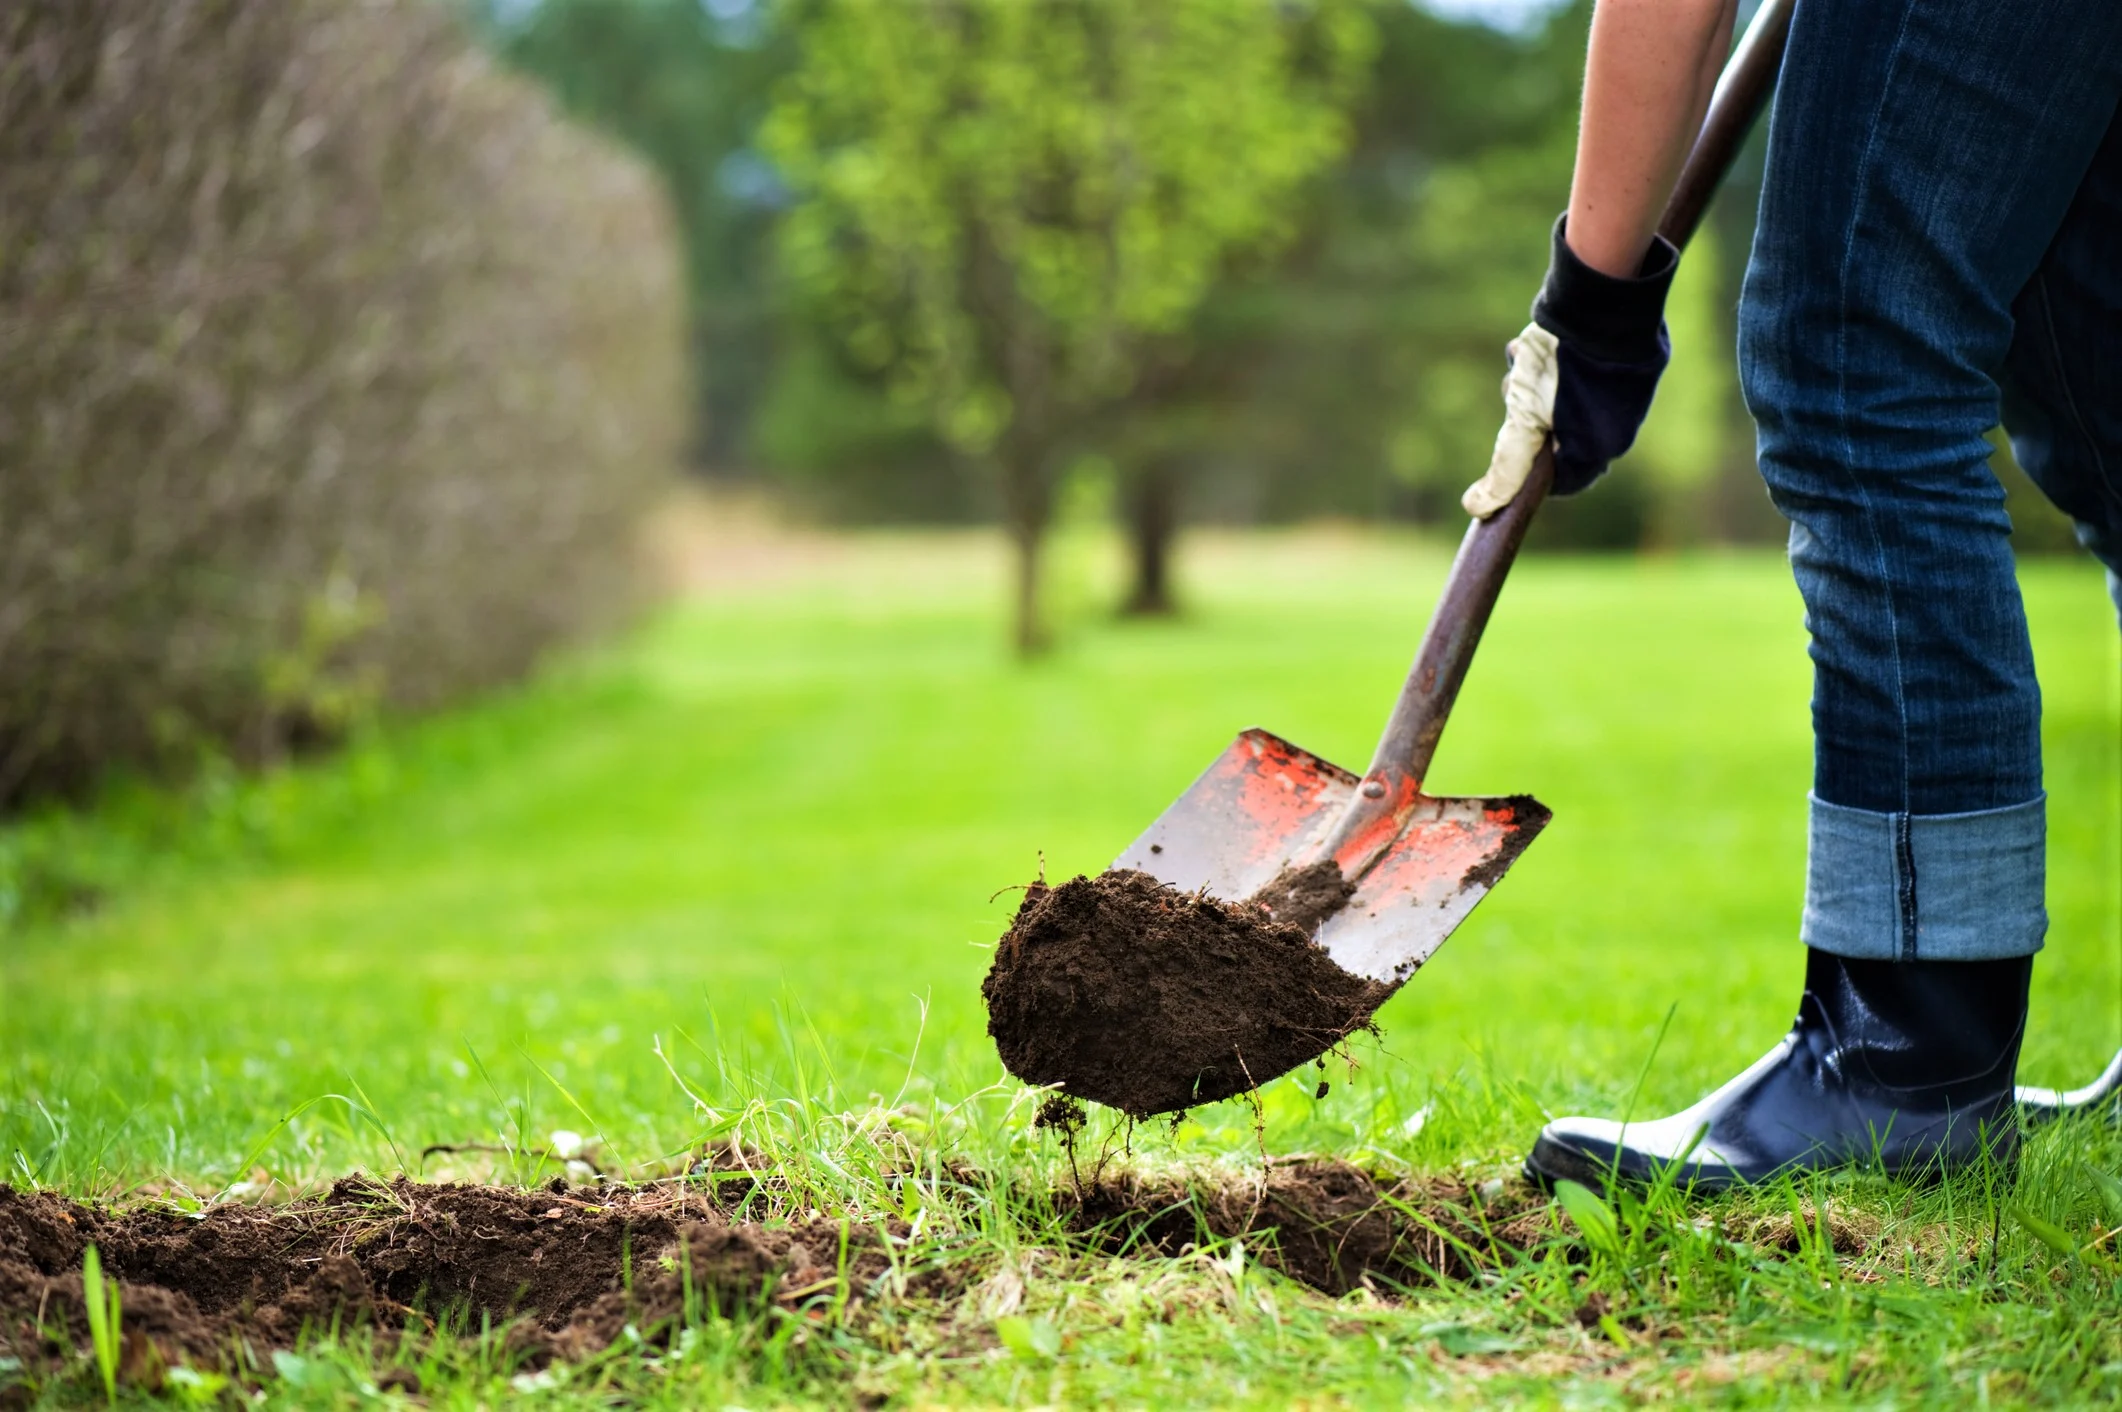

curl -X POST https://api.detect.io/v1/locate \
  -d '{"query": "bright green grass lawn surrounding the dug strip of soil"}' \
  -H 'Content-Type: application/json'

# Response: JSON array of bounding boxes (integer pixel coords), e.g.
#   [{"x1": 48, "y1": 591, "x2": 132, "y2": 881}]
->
[{"x1": 0, "y1": 535, "x2": 2122, "y2": 1406}]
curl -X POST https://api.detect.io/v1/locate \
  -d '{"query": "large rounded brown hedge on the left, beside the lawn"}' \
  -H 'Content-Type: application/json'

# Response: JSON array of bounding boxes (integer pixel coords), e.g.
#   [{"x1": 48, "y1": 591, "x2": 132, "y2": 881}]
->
[{"x1": 0, "y1": 0, "x2": 685, "y2": 803}]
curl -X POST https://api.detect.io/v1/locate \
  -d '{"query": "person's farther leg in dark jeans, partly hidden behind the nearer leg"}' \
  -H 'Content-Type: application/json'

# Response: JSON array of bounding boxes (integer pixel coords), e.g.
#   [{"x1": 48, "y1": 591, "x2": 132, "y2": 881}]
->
[{"x1": 2001, "y1": 110, "x2": 2122, "y2": 614}]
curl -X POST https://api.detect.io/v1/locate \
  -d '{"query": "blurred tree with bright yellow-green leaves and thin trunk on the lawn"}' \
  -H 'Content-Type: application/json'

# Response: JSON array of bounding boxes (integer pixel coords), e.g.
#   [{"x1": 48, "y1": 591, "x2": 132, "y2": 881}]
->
[{"x1": 762, "y1": 0, "x2": 1371, "y2": 652}]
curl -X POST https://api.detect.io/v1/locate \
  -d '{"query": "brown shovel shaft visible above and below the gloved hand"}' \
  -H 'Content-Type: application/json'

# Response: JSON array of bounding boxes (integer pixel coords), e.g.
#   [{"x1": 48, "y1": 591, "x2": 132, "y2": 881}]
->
[{"x1": 1328, "y1": 0, "x2": 1795, "y2": 802}]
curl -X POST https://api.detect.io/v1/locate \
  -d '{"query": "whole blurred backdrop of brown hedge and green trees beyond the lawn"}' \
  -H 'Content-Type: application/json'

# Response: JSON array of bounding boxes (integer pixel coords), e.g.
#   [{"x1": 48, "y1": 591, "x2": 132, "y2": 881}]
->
[{"x1": 0, "y1": 0, "x2": 2069, "y2": 805}]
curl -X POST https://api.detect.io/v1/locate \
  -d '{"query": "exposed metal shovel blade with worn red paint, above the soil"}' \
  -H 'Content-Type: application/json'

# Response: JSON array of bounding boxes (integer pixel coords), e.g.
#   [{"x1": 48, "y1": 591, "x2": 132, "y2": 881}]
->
[{"x1": 1112, "y1": 730, "x2": 1549, "y2": 985}]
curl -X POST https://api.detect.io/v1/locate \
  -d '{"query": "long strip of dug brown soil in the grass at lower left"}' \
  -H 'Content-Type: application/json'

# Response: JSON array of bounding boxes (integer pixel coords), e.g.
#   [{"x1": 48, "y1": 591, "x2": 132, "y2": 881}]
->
[{"x1": 0, "y1": 1176, "x2": 891, "y2": 1382}]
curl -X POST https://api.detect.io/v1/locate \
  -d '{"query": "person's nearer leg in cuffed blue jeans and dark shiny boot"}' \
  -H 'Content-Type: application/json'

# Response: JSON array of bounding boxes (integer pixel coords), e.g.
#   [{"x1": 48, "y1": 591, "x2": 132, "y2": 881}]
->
[{"x1": 1528, "y1": 0, "x2": 2122, "y2": 1187}]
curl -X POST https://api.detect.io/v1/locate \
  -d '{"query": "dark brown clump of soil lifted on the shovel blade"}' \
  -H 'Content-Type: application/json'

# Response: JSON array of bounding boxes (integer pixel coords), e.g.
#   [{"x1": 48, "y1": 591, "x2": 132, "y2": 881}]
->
[{"x1": 980, "y1": 864, "x2": 1392, "y2": 1117}]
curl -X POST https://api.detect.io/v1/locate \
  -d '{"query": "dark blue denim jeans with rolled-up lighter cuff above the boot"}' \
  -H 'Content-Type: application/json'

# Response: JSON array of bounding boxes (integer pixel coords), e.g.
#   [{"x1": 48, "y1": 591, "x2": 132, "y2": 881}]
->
[{"x1": 1740, "y1": 0, "x2": 2122, "y2": 960}]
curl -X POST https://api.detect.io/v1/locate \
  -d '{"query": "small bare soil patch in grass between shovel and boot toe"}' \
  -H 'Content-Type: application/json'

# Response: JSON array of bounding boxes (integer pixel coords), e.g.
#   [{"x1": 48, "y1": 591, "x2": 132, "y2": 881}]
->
[{"x1": 1055, "y1": 1157, "x2": 1551, "y2": 1295}]
